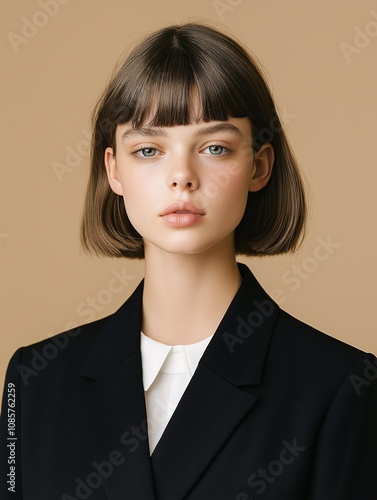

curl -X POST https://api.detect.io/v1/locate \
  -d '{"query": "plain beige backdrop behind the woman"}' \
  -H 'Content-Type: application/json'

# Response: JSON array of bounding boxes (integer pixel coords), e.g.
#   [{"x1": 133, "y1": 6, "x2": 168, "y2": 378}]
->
[{"x1": 0, "y1": 0, "x2": 377, "y2": 398}]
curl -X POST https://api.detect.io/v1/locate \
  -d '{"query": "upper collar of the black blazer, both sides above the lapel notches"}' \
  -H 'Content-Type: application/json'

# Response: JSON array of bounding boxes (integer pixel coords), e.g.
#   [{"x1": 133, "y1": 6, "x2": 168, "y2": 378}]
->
[{"x1": 80, "y1": 263, "x2": 279, "y2": 386}]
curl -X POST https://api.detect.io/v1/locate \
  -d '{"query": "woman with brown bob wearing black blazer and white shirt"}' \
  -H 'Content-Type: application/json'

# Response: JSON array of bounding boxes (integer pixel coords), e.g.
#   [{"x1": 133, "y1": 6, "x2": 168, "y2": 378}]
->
[{"x1": 2, "y1": 24, "x2": 377, "y2": 500}]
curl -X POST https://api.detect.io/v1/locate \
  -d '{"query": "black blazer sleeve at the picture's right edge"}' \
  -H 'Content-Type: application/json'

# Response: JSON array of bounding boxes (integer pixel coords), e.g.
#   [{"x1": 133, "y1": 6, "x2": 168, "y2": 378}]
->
[{"x1": 308, "y1": 354, "x2": 377, "y2": 500}]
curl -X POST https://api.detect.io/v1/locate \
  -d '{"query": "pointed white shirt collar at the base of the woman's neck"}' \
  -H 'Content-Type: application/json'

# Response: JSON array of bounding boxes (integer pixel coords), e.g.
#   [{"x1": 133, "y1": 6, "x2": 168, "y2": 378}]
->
[{"x1": 140, "y1": 332, "x2": 213, "y2": 391}]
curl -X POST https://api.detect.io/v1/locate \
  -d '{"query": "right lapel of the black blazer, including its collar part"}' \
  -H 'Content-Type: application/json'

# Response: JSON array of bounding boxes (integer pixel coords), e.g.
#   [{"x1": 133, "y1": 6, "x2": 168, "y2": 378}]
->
[{"x1": 151, "y1": 264, "x2": 279, "y2": 500}]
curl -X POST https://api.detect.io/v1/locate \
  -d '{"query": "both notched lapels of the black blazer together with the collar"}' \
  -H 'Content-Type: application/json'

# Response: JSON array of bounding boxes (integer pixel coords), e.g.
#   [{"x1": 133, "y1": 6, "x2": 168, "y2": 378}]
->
[{"x1": 74, "y1": 264, "x2": 279, "y2": 500}]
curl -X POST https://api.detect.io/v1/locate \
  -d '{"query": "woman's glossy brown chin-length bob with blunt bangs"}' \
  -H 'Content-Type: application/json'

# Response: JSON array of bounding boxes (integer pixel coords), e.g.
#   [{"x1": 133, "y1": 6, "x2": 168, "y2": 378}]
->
[{"x1": 81, "y1": 23, "x2": 306, "y2": 258}]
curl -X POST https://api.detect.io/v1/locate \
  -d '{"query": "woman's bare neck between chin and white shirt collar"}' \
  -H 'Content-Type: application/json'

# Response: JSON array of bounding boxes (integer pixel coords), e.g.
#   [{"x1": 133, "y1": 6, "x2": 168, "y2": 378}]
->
[{"x1": 142, "y1": 240, "x2": 241, "y2": 345}]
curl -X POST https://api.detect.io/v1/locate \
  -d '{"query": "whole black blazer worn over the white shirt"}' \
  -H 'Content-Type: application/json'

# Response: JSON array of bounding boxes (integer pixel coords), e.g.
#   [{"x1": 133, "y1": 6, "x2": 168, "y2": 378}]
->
[{"x1": 0, "y1": 264, "x2": 377, "y2": 500}]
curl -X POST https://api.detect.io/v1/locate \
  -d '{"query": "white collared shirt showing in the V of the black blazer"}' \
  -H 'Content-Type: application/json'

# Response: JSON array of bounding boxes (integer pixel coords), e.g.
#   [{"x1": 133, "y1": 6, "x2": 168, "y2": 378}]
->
[{"x1": 140, "y1": 332, "x2": 213, "y2": 454}]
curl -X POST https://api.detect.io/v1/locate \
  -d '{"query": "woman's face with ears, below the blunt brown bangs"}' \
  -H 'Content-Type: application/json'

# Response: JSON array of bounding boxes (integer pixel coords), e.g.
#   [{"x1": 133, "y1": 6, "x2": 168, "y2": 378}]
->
[{"x1": 105, "y1": 113, "x2": 273, "y2": 254}]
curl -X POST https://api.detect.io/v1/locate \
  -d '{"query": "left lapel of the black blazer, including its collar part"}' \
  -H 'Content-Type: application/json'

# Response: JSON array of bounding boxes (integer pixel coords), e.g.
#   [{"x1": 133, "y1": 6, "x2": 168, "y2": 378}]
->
[{"x1": 74, "y1": 282, "x2": 156, "y2": 500}]
